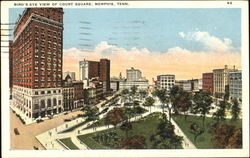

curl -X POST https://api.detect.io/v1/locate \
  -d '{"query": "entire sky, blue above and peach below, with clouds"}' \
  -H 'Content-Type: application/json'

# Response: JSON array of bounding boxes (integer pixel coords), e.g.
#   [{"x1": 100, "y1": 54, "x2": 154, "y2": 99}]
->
[{"x1": 9, "y1": 8, "x2": 241, "y2": 80}]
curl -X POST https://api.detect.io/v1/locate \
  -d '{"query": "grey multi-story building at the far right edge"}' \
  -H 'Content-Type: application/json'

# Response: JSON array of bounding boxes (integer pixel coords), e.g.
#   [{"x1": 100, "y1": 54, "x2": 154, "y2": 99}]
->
[{"x1": 228, "y1": 70, "x2": 242, "y2": 99}]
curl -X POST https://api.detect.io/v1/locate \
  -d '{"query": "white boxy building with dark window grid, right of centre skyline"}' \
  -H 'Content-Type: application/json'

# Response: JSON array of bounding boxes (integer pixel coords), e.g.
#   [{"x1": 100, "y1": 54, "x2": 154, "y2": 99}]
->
[{"x1": 157, "y1": 74, "x2": 175, "y2": 92}]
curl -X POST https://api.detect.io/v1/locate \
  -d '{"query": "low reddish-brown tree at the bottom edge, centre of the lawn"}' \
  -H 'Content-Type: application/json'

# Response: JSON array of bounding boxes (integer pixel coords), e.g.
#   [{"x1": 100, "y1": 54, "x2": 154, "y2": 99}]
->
[{"x1": 118, "y1": 135, "x2": 146, "y2": 149}]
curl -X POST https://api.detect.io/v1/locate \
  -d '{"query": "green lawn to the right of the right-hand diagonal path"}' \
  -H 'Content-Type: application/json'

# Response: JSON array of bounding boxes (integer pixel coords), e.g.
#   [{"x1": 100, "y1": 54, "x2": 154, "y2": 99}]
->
[{"x1": 173, "y1": 115, "x2": 242, "y2": 149}]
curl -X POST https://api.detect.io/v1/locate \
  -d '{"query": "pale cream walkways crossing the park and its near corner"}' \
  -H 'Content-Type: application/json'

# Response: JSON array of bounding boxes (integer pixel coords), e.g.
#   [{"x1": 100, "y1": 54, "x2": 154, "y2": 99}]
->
[{"x1": 36, "y1": 94, "x2": 196, "y2": 150}]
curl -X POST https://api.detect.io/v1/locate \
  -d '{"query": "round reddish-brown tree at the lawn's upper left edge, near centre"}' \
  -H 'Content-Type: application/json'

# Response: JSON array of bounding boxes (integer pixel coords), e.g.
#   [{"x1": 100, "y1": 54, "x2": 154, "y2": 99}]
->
[{"x1": 106, "y1": 108, "x2": 125, "y2": 128}]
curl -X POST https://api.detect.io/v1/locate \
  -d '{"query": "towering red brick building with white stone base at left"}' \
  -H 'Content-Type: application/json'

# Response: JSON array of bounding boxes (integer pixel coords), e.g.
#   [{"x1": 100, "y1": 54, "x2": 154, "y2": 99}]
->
[{"x1": 11, "y1": 8, "x2": 63, "y2": 124}]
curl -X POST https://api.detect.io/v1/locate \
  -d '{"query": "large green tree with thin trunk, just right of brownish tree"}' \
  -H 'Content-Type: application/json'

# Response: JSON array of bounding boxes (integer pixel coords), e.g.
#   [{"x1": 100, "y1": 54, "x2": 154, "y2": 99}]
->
[{"x1": 192, "y1": 91, "x2": 213, "y2": 127}]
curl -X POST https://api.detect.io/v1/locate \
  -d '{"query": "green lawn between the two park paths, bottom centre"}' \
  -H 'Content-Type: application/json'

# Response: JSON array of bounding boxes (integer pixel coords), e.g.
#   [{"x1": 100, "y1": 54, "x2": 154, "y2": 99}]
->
[{"x1": 78, "y1": 113, "x2": 174, "y2": 149}]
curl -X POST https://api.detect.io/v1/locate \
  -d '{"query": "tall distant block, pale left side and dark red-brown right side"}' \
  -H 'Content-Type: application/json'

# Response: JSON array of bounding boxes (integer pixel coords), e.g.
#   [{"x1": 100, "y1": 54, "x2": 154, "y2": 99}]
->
[{"x1": 79, "y1": 59, "x2": 110, "y2": 94}]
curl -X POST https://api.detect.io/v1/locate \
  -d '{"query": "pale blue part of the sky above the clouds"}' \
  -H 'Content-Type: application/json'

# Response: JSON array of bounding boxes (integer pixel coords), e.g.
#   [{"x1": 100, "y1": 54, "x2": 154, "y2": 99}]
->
[{"x1": 9, "y1": 8, "x2": 241, "y2": 52}]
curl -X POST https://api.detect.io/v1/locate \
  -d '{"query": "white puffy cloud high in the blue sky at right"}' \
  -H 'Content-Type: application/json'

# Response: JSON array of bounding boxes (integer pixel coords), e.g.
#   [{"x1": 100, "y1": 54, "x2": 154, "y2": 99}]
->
[{"x1": 184, "y1": 31, "x2": 238, "y2": 52}]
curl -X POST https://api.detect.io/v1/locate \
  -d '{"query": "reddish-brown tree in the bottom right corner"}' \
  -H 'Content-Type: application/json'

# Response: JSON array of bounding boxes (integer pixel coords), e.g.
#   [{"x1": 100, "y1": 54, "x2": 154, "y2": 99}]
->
[{"x1": 212, "y1": 124, "x2": 242, "y2": 148}]
